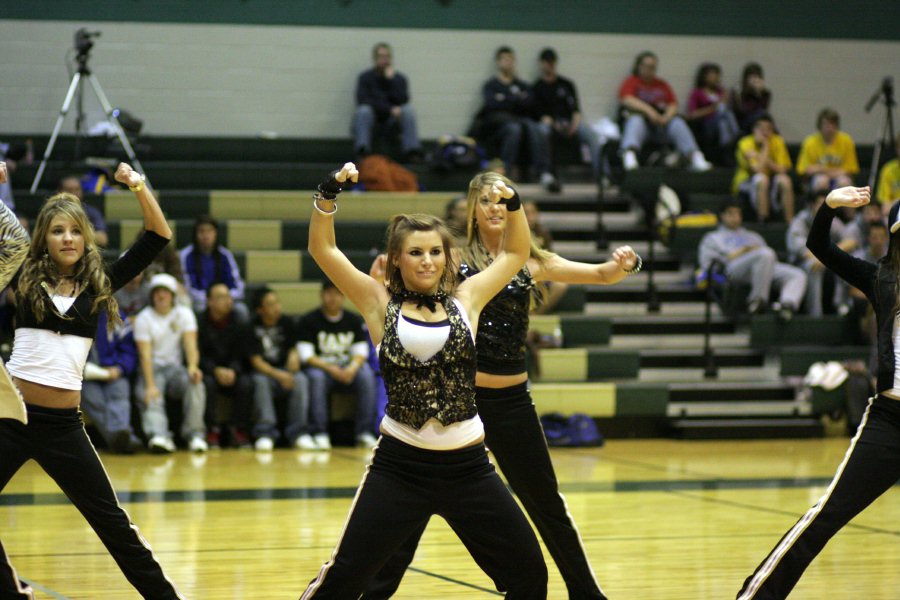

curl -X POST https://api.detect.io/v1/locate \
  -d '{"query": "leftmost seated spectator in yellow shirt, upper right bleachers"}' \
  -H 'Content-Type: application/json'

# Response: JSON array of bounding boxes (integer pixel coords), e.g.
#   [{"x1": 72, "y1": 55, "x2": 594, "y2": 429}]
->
[{"x1": 731, "y1": 115, "x2": 794, "y2": 223}]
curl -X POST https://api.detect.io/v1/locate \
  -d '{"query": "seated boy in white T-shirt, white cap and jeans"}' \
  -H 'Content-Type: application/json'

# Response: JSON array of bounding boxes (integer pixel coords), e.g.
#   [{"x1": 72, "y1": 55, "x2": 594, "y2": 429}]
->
[{"x1": 134, "y1": 273, "x2": 208, "y2": 453}]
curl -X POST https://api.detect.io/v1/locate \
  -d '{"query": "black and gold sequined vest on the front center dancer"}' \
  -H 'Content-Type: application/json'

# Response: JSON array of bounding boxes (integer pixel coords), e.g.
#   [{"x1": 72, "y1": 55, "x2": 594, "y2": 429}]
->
[{"x1": 378, "y1": 298, "x2": 477, "y2": 429}]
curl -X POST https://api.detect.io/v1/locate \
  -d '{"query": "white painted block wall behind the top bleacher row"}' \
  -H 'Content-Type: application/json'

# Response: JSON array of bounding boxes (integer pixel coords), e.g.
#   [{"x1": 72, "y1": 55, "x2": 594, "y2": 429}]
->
[{"x1": 0, "y1": 20, "x2": 900, "y2": 143}]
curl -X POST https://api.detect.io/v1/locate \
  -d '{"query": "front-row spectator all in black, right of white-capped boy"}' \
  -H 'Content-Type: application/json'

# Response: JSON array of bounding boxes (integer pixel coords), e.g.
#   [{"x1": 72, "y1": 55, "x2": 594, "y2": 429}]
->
[{"x1": 197, "y1": 283, "x2": 253, "y2": 448}]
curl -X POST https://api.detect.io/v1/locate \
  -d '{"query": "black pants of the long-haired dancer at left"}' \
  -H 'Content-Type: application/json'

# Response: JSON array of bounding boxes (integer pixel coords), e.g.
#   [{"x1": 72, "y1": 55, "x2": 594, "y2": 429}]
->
[{"x1": 0, "y1": 404, "x2": 182, "y2": 600}]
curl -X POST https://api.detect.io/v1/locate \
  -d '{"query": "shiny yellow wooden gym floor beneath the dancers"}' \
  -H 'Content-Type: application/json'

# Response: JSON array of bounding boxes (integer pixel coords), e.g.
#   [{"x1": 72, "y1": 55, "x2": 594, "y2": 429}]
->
[{"x1": 0, "y1": 438, "x2": 900, "y2": 600}]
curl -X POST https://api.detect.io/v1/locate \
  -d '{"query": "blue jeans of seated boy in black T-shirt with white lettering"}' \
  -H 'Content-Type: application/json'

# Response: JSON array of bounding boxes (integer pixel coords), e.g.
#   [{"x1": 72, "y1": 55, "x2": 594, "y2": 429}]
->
[{"x1": 305, "y1": 363, "x2": 377, "y2": 435}]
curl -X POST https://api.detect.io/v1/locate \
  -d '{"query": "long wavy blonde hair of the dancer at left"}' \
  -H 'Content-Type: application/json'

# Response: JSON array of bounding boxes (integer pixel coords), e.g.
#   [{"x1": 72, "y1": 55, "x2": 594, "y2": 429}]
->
[{"x1": 16, "y1": 192, "x2": 122, "y2": 329}]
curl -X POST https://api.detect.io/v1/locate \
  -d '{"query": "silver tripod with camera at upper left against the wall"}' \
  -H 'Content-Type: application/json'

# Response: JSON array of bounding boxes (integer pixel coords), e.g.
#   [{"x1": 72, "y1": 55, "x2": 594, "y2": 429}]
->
[{"x1": 31, "y1": 30, "x2": 149, "y2": 194}]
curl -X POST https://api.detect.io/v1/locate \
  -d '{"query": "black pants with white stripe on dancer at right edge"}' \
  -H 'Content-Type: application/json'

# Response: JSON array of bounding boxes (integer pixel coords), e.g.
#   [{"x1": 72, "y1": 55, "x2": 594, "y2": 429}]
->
[{"x1": 737, "y1": 396, "x2": 900, "y2": 600}]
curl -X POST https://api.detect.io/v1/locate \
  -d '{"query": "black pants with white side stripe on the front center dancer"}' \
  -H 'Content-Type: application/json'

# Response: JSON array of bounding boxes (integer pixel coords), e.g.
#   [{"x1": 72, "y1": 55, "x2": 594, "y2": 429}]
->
[{"x1": 301, "y1": 436, "x2": 547, "y2": 600}]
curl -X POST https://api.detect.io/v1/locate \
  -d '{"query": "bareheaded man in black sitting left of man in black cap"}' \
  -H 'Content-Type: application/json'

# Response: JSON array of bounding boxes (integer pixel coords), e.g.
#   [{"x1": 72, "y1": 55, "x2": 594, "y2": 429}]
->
[{"x1": 469, "y1": 46, "x2": 559, "y2": 191}]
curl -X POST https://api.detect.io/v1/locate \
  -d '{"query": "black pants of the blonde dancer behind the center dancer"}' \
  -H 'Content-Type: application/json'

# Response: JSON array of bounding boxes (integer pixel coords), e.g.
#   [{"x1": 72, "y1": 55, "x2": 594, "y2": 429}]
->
[{"x1": 363, "y1": 382, "x2": 606, "y2": 600}]
